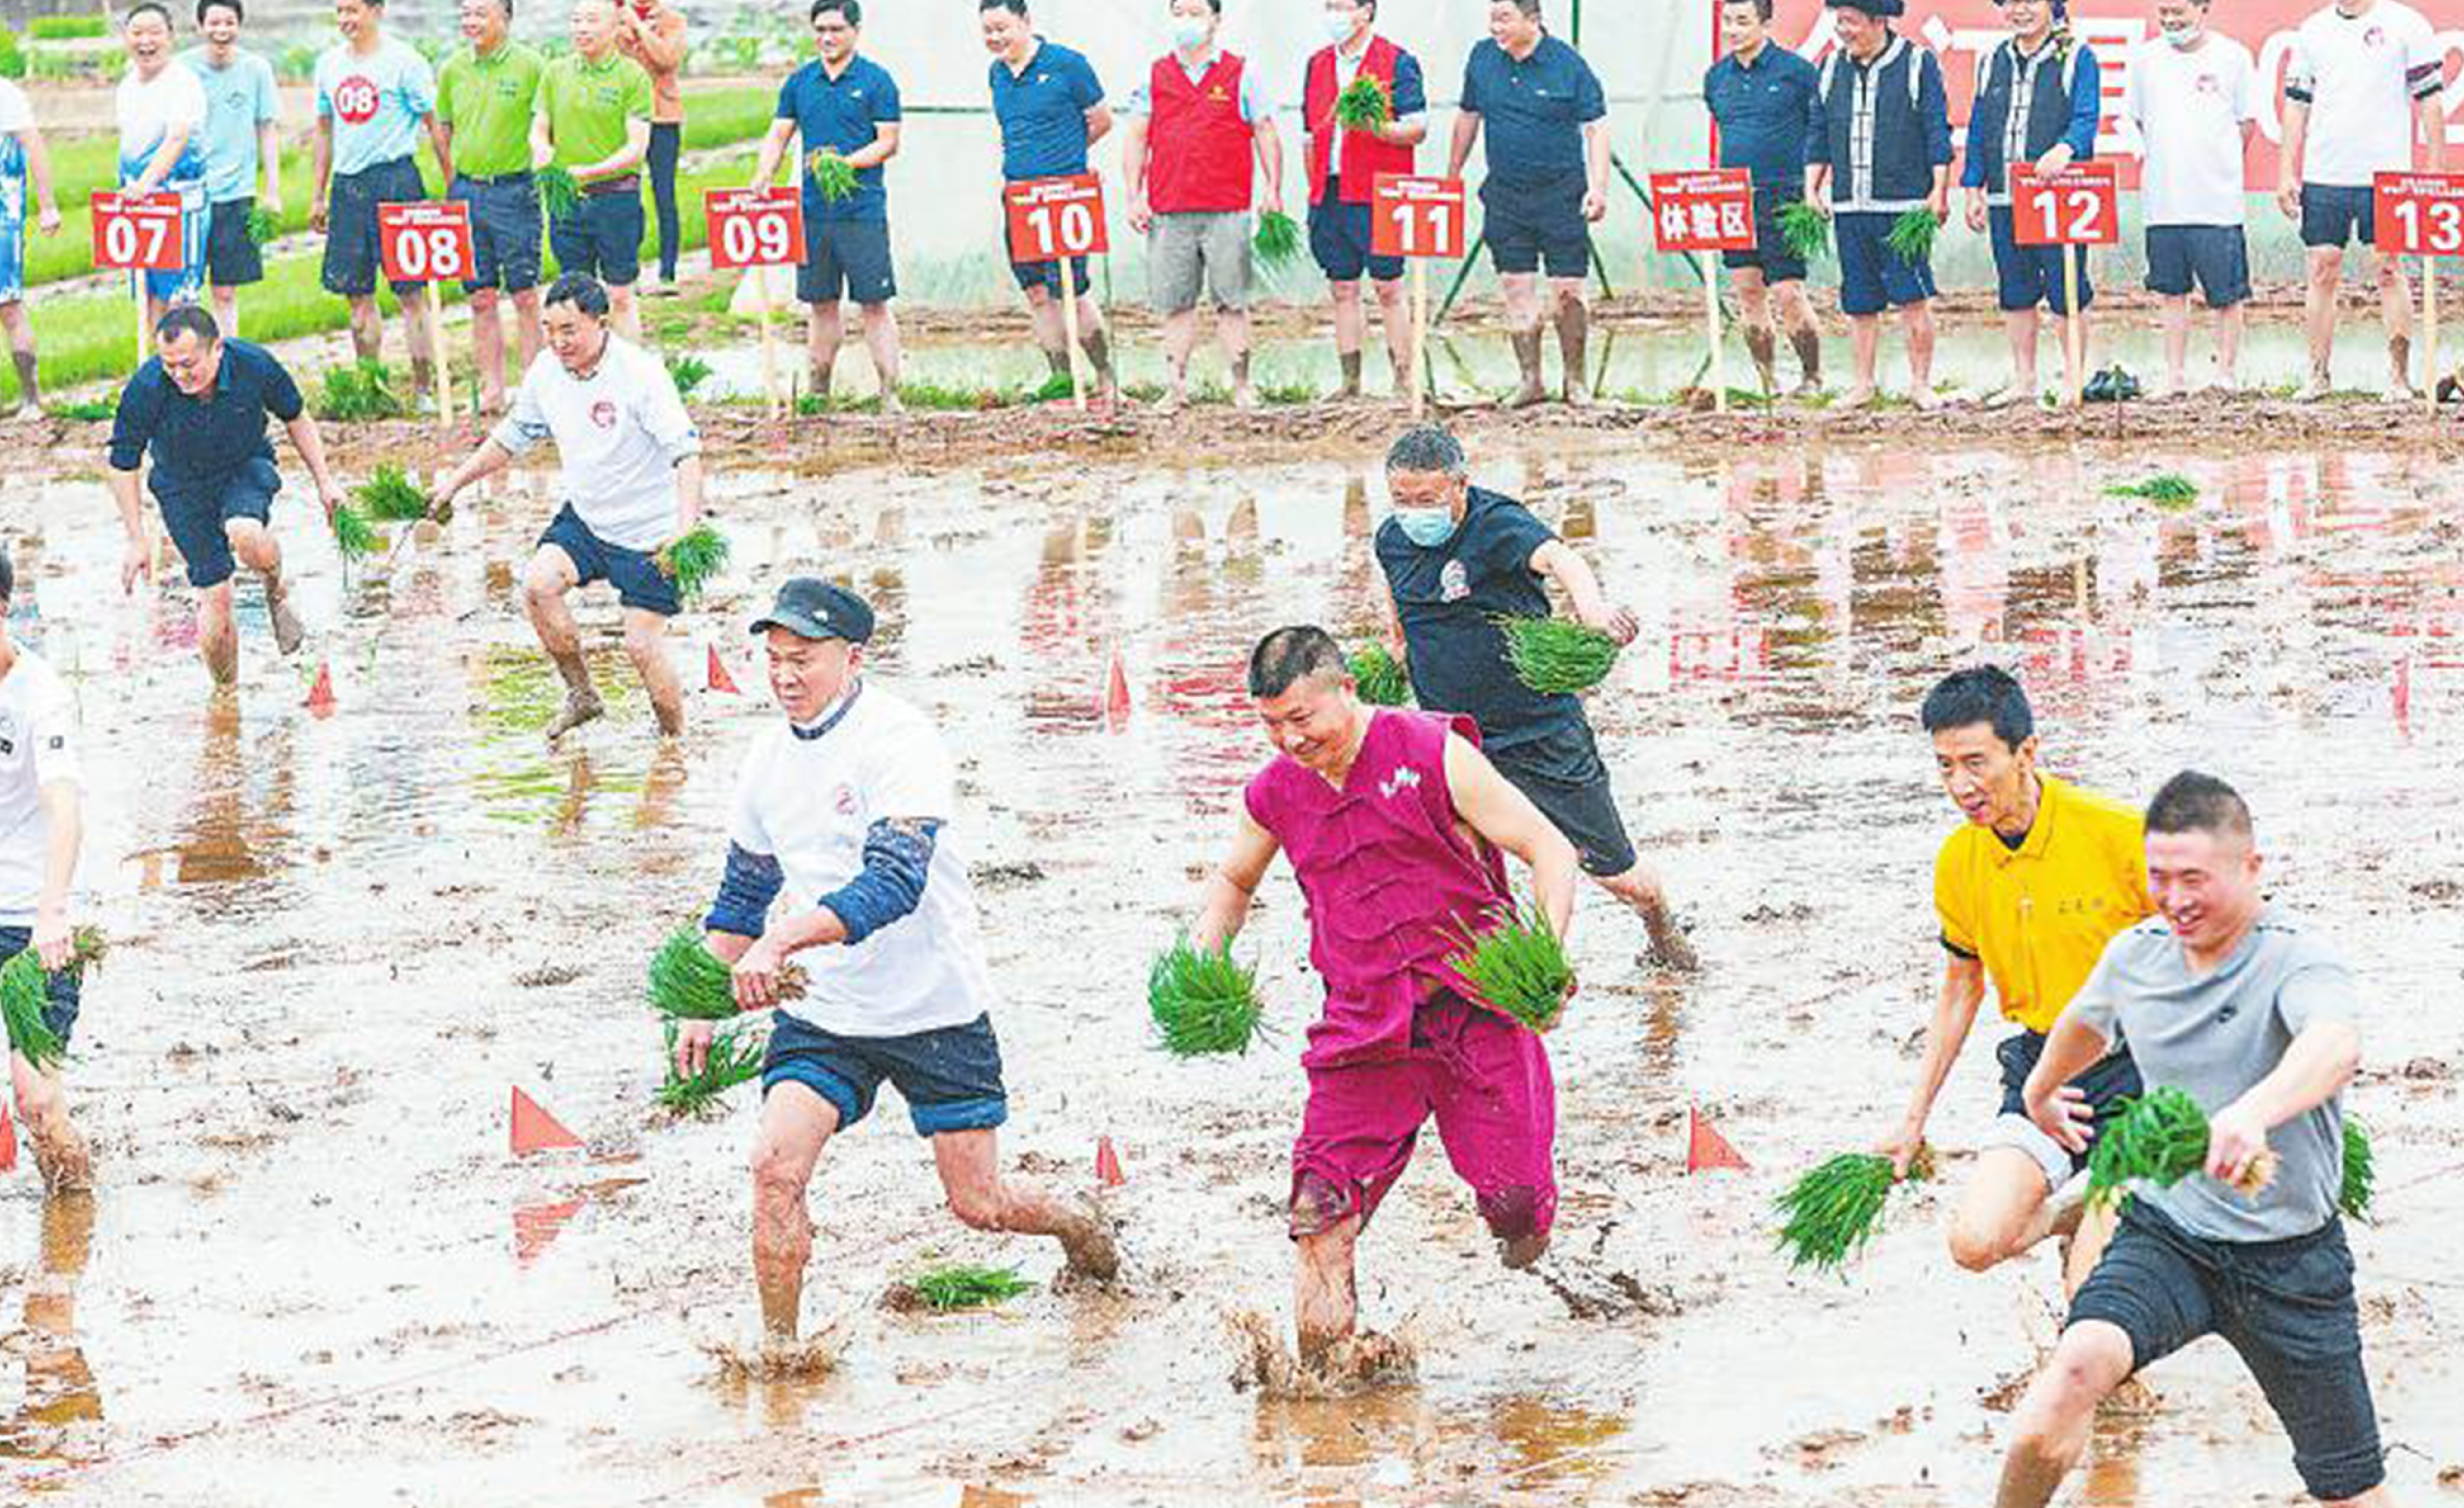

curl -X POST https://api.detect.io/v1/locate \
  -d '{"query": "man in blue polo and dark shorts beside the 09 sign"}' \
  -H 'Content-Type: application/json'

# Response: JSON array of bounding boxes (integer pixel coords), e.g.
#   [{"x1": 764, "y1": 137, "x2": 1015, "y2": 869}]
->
[{"x1": 754, "y1": 0, "x2": 899, "y2": 414}]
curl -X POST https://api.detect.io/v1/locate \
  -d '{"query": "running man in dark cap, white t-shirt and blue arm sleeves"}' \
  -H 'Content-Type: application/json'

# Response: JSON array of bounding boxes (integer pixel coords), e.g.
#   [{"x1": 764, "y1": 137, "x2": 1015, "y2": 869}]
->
[{"x1": 675, "y1": 577, "x2": 1116, "y2": 1343}]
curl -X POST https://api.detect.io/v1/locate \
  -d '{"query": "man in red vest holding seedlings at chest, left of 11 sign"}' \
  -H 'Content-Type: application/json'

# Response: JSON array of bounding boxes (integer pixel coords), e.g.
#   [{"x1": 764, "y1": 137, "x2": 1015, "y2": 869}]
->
[{"x1": 1301, "y1": 0, "x2": 1429, "y2": 397}]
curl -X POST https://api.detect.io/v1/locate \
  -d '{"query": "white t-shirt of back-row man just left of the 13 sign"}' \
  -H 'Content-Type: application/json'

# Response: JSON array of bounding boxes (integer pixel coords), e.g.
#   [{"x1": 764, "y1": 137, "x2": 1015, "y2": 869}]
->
[{"x1": 2284, "y1": 0, "x2": 2447, "y2": 187}]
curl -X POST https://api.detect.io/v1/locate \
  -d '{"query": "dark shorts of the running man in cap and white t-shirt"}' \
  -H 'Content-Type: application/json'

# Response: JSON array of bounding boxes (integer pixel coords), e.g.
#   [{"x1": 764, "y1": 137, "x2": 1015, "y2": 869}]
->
[{"x1": 761, "y1": 1010, "x2": 1010, "y2": 1136}]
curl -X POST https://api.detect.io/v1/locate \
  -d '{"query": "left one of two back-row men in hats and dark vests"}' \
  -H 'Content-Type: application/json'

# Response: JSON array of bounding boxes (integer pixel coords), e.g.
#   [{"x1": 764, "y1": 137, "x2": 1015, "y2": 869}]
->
[{"x1": 1806, "y1": 0, "x2": 1951, "y2": 409}]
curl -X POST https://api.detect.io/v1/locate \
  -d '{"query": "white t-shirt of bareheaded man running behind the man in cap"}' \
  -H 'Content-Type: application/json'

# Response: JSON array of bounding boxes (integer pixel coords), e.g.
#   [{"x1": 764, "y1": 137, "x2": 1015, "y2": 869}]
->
[{"x1": 490, "y1": 333, "x2": 702, "y2": 550}]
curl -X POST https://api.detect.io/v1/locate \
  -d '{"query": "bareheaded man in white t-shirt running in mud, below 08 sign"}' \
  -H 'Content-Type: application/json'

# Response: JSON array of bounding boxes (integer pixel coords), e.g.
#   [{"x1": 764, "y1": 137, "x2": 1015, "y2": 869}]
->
[{"x1": 436, "y1": 273, "x2": 702, "y2": 739}]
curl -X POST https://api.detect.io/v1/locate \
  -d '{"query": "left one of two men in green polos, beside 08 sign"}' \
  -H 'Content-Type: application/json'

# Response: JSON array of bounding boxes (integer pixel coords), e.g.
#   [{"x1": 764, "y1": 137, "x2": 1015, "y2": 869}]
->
[{"x1": 436, "y1": 0, "x2": 547, "y2": 414}]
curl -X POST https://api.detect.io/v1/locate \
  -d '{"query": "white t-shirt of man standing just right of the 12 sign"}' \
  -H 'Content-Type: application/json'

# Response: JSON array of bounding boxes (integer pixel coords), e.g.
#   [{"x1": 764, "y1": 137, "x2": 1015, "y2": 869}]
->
[{"x1": 2121, "y1": 32, "x2": 2259, "y2": 224}]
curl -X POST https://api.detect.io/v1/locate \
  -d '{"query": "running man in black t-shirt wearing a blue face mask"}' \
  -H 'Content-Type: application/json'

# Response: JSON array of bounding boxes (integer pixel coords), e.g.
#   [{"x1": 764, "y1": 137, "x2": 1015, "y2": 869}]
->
[{"x1": 1375, "y1": 424, "x2": 1695, "y2": 971}]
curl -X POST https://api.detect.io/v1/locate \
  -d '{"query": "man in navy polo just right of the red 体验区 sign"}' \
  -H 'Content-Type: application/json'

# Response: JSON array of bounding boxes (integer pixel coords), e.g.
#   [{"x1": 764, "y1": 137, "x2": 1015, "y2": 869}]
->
[{"x1": 1703, "y1": 0, "x2": 1823, "y2": 397}]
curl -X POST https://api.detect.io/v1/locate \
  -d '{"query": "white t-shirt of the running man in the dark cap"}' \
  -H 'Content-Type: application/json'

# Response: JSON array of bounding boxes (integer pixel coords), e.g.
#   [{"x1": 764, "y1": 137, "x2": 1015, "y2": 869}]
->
[{"x1": 729, "y1": 683, "x2": 993, "y2": 1038}]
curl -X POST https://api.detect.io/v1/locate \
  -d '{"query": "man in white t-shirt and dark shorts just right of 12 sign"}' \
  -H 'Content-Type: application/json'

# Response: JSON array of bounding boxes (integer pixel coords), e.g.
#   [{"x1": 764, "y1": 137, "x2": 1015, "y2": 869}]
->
[{"x1": 2121, "y1": 0, "x2": 2259, "y2": 392}]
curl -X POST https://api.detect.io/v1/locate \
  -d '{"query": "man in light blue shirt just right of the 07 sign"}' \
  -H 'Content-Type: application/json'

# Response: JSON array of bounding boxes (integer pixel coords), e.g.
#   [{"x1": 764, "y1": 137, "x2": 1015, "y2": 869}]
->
[{"x1": 180, "y1": 0, "x2": 283, "y2": 335}]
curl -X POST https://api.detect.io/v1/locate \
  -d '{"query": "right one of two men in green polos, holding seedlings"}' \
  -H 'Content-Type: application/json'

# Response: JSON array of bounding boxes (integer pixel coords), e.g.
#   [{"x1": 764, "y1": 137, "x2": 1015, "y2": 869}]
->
[{"x1": 530, "y1": 0, "x2": 650, "y2": 340}]
